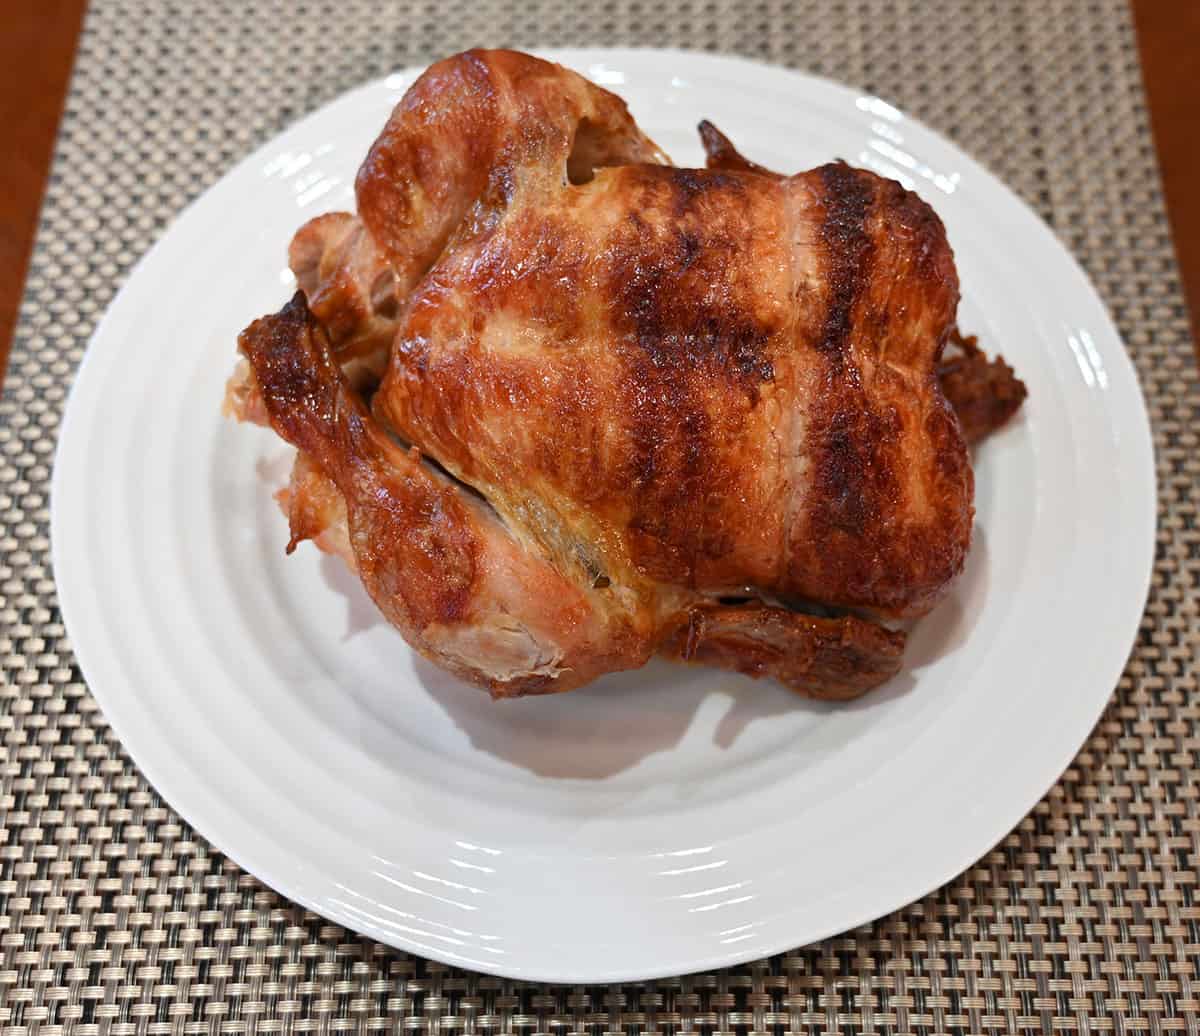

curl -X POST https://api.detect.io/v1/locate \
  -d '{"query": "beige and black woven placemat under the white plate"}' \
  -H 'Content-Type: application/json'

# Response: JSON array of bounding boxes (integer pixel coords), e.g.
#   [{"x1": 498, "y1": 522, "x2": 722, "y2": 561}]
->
[{"x1": 0, "y1": 0, "x2": 1200, "y2": 1036}]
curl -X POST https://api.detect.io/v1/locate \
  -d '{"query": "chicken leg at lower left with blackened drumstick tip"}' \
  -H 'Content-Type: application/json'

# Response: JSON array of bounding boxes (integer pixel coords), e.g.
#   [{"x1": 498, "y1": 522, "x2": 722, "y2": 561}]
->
[{"x1": 240, "y1": 293, "x2": 652, "y2": 694}]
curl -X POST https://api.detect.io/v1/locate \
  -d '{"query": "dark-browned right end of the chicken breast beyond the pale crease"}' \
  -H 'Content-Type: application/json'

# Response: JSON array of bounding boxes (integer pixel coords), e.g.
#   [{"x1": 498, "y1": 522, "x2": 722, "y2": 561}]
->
[{"x1": 788, "y1": 163, "x2": 972, "y2": 615}]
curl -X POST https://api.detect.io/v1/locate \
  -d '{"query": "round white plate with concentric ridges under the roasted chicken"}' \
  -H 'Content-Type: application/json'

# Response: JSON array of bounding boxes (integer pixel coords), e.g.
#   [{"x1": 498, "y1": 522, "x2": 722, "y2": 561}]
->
[{"x1": 53, "y1": 50, "x2": 1154, "y2": 982}]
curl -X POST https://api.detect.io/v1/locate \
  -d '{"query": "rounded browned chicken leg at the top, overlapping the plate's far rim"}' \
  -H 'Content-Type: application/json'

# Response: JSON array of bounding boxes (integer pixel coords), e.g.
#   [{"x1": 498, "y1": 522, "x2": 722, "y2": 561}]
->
[{"x1": 355, "y1": 50, "x2": 667, "y2": 285}]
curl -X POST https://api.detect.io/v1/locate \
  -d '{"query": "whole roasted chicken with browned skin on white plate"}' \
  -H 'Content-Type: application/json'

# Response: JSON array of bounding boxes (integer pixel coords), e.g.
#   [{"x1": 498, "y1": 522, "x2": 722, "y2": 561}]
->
[{"x1": 227, "y1": 50, "x2": 1024, "y2": 697}]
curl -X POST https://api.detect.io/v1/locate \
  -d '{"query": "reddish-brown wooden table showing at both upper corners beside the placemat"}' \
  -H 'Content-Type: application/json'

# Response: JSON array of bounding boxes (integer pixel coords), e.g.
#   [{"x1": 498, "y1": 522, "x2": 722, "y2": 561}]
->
[{"x1": 0, "y1": 0, "x2": 1200, "y2": 384}]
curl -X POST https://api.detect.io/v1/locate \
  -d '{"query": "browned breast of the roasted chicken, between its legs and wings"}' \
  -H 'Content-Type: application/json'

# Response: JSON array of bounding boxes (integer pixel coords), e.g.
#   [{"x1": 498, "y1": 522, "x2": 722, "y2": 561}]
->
[{"x1": 373, "y1": 158, "x2": 972, "y2": 616}]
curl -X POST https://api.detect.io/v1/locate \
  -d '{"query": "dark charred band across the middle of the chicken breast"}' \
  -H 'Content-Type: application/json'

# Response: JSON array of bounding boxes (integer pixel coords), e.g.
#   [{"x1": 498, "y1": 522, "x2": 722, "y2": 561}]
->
[{"x1": 604, "y1": 167, "x2": 781, "y2": 586}]
